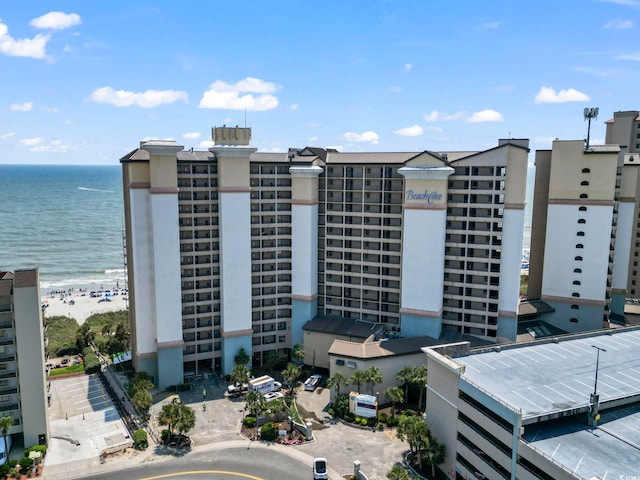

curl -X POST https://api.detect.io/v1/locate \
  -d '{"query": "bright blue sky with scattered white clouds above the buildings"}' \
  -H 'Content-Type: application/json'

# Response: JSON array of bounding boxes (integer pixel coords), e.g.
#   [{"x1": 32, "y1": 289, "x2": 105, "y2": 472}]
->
[{"x1": 0, "y1": 0, "x2": 640, "y2": 164}]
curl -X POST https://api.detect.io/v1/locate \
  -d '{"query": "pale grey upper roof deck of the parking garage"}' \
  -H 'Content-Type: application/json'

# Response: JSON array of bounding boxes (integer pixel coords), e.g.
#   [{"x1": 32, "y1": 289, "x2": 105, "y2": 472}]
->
[{"x1": 455, "y1": 328, "x2": 640, "y2": 424}]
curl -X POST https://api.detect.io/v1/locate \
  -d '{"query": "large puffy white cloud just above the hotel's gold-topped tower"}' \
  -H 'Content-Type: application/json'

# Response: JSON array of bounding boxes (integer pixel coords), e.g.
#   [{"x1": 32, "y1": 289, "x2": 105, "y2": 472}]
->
[{"x1": 198, "y1": 77, "x2": 278, "y2": 112}]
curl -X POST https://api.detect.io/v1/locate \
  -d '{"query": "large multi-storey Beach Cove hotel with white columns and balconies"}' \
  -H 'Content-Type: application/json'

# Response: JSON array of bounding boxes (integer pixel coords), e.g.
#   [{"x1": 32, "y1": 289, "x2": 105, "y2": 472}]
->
[{"x1": 121, "y1": 127, "x2": 528, "y2": 386}]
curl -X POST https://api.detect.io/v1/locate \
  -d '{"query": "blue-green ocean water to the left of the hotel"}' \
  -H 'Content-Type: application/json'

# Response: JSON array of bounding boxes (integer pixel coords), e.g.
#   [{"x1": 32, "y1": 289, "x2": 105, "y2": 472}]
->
[{"x1": 0, "y1": 165, "x2": 125, "y2": 292}]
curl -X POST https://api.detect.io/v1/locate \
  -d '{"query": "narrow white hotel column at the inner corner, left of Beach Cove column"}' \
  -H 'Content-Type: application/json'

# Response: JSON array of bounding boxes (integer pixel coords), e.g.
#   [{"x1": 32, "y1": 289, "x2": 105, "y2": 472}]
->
[{"x1": 289, "y1": 166, "x2": 322, "y2": 346}]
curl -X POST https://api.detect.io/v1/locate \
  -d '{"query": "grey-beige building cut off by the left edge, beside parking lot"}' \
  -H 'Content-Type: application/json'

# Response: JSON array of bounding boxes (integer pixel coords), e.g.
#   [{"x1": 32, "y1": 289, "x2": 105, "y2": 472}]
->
[{"x1": 0, "y1": 269, "x2": 49, "y2": 447}]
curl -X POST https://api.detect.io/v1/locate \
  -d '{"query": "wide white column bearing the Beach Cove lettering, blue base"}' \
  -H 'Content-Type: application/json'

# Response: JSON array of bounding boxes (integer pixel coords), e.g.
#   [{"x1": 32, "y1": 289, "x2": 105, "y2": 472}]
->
[{"x1": 398, "y1": 166, "x2": 454, "y2": 338}]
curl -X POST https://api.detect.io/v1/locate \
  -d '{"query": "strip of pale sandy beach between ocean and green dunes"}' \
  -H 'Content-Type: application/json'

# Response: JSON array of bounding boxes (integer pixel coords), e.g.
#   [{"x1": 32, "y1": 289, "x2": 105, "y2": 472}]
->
[{"x1": 40, "y1": 289, "x2": 129, "y2": 325}]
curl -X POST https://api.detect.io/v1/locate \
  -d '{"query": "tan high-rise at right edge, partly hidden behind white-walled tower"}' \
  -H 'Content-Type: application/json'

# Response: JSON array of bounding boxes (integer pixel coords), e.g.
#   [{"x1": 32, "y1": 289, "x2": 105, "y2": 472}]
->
[{"x1": 605, "y1": 111, "x2": 640, "y2": 298}]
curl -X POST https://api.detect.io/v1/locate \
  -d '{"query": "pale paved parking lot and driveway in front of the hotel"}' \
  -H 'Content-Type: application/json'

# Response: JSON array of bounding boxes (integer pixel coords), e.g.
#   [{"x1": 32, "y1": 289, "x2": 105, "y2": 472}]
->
[{"x1": 45, "y1": 375, "x2": 408, "y2": 480}]
